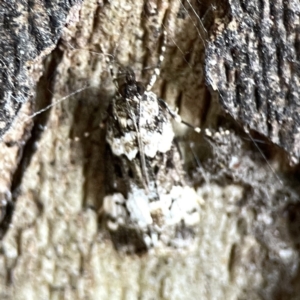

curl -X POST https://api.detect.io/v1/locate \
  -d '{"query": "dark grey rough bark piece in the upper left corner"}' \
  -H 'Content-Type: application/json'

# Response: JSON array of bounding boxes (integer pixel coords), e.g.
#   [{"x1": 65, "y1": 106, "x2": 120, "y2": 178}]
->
[{"x1": 0, "y1": 0, "x2": 80, "y2": 137}]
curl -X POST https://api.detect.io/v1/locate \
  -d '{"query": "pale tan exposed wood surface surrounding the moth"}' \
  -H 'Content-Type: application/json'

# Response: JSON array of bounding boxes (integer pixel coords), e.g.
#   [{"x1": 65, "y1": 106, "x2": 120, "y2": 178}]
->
[{"x1": 0, "y1": 0, "x2": 300, "y2": 300}]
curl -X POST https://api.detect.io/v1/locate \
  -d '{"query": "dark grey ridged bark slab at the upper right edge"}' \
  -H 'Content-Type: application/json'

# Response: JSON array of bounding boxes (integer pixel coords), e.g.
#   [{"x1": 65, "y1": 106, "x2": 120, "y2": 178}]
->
[{"x1": 206, "y1": 0, "x2": 300, "y2": 164}]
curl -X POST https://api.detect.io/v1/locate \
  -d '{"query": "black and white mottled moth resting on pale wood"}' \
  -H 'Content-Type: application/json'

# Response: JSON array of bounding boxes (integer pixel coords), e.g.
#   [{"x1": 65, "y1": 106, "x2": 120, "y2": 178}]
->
[{"x1": 103, "y1": 31, "x2": 199, "y2": 252}]
